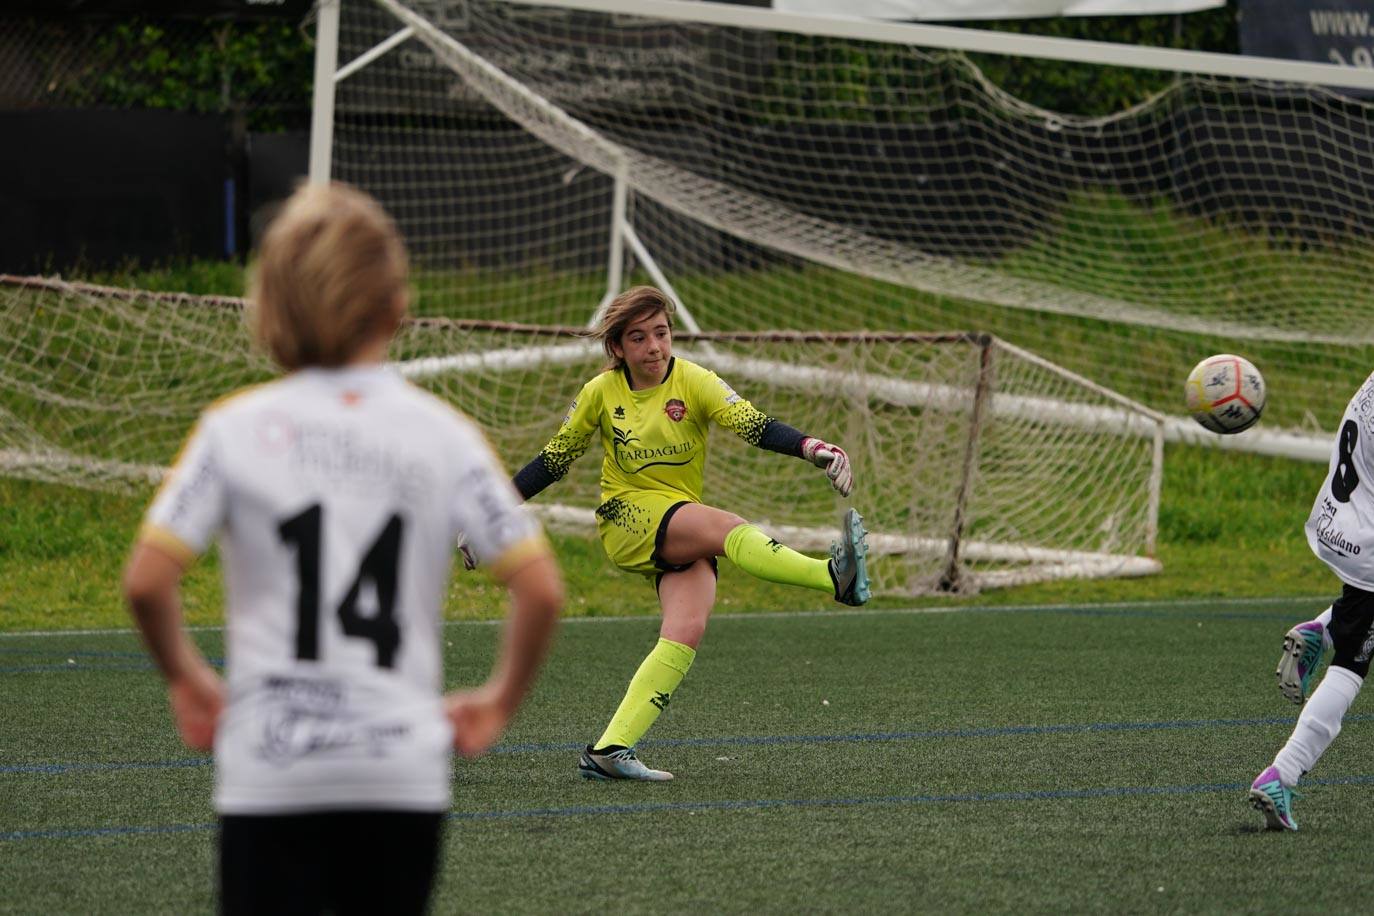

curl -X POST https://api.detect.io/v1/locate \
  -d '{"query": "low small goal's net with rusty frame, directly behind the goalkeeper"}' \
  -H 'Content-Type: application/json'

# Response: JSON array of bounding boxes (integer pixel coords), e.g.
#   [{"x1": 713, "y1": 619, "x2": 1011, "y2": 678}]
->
[{"x1": 0, "y1": 277, "x2": 1162, "y2": 595}]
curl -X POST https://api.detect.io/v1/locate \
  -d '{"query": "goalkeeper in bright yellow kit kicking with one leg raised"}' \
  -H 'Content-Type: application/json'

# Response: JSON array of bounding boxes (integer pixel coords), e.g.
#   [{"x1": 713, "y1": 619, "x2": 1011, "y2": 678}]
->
[{"x1": 515, "y1": 287, "x2": 868, "y2": 780}]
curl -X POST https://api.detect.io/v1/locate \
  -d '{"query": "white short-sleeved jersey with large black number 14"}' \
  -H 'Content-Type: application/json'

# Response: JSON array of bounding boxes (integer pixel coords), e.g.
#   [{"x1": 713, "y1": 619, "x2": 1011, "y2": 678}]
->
[{"x1": 142, "y1": 367, "x2": 545, "y2": 814}]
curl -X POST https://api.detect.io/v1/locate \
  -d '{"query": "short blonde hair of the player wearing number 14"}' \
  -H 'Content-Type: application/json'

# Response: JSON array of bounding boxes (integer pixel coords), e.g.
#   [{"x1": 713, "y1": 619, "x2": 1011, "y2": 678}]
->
[{"x1": 249, "y1": 183, "x2": 408, "y2": 371}]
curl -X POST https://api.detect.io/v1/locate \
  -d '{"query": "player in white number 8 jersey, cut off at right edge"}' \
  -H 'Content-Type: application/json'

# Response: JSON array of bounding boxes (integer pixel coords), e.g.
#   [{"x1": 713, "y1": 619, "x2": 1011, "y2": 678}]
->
[{"x1": 1250, "y1": 375, "x2": 1374, "y2": 829}]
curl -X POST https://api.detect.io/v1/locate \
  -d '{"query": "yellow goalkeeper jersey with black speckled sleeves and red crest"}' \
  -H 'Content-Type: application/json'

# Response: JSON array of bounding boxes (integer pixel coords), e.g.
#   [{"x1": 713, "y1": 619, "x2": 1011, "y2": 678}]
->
[{"x1": 540, "y1": 356, "x2": 769, "y2": 503}]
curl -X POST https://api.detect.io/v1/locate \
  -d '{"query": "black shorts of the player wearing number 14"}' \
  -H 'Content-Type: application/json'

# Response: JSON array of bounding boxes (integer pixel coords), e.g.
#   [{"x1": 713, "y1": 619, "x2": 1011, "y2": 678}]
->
[{"x1": 220, "y1": 812, "x2": 444, "y2": 916}]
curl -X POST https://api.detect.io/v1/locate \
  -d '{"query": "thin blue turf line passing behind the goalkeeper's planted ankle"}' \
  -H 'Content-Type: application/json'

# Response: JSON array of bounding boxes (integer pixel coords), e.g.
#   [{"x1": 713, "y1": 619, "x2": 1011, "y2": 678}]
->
[{"x1": 8, "y1": 713, "x2": 1374, "y2": 776}]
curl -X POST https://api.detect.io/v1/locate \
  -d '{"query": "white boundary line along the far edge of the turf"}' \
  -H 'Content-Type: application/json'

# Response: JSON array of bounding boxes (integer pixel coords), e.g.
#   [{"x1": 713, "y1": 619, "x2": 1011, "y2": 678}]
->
[{"x1": 0, "y1": 595, "x2": 1331, "y2": 639}]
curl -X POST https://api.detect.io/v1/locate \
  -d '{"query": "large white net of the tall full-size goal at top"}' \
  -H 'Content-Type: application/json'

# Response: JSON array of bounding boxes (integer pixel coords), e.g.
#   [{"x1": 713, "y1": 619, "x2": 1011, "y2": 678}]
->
[{"x1": 330, "y1": 0, "x2": 1374, "y2": 460}]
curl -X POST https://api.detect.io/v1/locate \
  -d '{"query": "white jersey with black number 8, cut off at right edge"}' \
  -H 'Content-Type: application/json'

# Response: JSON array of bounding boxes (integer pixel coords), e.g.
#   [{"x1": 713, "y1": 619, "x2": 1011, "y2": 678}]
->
[{"x1": 1307, "y1": 375, "x2": 1374, "y2": 592}]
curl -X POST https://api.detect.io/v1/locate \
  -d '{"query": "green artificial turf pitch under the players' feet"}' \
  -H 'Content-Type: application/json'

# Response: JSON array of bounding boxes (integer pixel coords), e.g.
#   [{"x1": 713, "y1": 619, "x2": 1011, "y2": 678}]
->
[{"x1": 0, "y1": 600, "x2": 1374, "y2": 913}]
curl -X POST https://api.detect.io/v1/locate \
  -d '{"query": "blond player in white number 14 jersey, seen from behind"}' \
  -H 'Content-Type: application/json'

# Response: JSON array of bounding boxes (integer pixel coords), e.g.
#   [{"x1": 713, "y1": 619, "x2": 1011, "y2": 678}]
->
[{"x1": 125, "y1": 185, "x2": 563, "y2": 913}]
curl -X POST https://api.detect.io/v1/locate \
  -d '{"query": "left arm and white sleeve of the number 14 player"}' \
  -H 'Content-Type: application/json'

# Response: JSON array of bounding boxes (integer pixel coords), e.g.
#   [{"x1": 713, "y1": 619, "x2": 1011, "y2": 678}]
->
[{"x1": 124, "y1": 420, "x2": 224, "y2": 750}]
